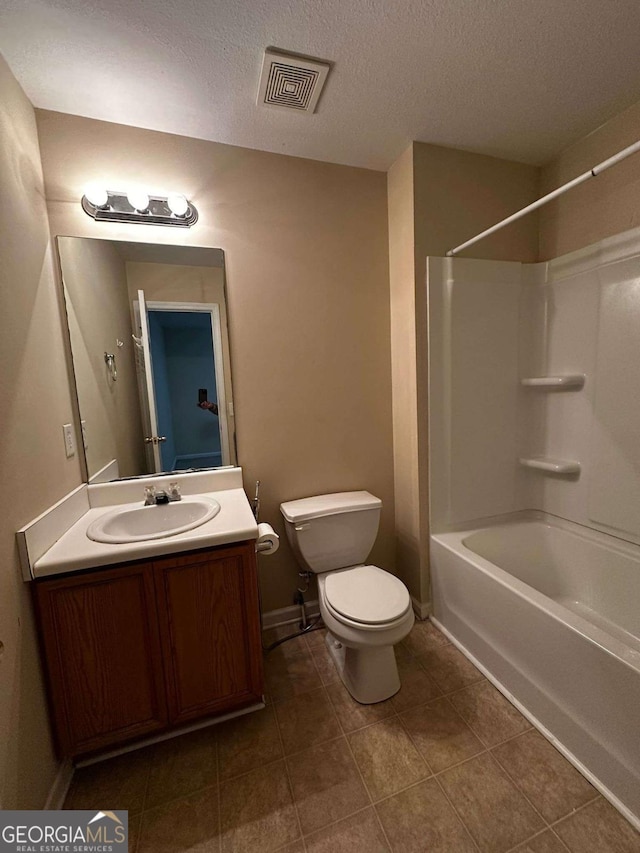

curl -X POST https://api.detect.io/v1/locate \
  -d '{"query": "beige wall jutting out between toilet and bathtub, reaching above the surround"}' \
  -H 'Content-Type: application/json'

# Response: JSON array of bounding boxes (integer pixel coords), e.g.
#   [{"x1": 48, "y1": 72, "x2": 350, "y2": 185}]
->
[{"x1": 388, "y1": 142, "x2": 539, "y2": 604}]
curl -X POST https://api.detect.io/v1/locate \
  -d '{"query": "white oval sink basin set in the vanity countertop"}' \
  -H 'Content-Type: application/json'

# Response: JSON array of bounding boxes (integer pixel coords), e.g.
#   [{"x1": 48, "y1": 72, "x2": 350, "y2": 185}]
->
[{"x1": 87, "y1": 496, "x2": 220, "y2": 544}]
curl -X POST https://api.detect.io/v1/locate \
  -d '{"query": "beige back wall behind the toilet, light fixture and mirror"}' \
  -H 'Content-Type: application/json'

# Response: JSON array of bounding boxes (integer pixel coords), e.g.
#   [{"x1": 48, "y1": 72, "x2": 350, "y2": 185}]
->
[{"x1": 38, "y1": 112, "x2": 394, "y2": 610}]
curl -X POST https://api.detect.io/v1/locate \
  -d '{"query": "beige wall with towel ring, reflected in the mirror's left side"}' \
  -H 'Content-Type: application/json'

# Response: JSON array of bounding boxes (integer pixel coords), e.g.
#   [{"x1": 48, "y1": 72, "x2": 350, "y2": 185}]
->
[{"x1": 58, "y1": 238, "x2": 144, "y2": 477}]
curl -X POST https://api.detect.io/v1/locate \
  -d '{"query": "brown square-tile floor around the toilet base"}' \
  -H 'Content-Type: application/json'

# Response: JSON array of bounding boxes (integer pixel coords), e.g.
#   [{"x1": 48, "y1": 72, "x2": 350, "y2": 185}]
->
[{"x1": 65, "y1": 622, "x2": 640, "y2": 853}]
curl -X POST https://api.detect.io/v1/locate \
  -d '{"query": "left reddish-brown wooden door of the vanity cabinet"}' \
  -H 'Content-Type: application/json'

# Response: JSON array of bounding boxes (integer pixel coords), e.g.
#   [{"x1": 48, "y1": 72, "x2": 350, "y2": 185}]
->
[{"x1": 34, "y1": 563, "x2": 167, "y2": 755}]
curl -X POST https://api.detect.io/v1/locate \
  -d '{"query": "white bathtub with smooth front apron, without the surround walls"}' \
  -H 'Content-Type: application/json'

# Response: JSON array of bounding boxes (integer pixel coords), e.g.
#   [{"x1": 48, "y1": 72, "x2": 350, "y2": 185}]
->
[{"x1": 431, "y1": 513, "x2": 640, "y2": 826}]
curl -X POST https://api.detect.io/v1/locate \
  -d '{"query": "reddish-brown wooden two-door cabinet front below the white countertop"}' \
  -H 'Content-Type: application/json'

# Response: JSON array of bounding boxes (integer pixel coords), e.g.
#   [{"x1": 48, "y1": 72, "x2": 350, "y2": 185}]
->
[{"x1": 33, "y1": 542, "x2": 263, "y2": 756}]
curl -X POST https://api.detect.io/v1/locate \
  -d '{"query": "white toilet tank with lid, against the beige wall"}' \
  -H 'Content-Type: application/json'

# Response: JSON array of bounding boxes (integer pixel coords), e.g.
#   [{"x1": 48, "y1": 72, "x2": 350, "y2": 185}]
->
[{"x1": 280, "y1": 492, "x2": 382, "y2": 574}]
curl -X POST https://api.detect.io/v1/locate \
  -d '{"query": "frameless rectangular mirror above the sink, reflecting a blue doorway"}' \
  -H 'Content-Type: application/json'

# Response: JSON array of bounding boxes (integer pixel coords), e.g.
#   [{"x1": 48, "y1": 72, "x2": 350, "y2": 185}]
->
[{"x1": 57, "y1": 237, "x2": 237, "y2": 483}]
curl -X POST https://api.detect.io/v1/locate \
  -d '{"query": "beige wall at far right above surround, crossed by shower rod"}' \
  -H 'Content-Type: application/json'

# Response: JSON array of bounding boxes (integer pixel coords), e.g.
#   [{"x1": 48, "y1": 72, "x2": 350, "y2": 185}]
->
[{"x1": 539, "y1": 95, "x2": 640, "y2": 261}]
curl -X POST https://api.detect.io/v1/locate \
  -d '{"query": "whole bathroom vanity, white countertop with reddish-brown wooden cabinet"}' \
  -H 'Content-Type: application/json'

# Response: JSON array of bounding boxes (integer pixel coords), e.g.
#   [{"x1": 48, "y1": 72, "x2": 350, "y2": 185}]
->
[{"x1": 19, "y1": 468, "x2": 263, "y2": 757}]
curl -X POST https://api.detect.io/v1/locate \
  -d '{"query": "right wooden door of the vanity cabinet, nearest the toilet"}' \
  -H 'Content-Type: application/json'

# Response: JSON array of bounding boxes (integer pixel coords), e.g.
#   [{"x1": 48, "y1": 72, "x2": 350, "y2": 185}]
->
[{"x1": 155, "y1": 542, "x2": 262, "y2": 723}]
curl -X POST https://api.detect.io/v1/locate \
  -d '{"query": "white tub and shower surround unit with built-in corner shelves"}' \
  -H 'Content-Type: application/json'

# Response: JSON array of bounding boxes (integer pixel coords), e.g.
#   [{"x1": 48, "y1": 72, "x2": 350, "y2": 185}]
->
[{"x1": 427, "y1": 229, "x2": 640, "y2": 826}]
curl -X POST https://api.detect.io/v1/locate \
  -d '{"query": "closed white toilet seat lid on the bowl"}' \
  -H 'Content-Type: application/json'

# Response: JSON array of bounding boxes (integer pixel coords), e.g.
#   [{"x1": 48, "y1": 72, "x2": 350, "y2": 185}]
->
[{"x1": 323, "y1": 566, "x2": 411, "y2": 631}]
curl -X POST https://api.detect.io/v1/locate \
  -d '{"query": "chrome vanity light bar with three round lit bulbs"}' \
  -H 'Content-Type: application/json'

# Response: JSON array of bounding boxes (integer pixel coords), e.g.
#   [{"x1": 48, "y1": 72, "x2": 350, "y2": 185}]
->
[{"x1": 81, "y1": 185, "x2": 198, "y2": 228}]
